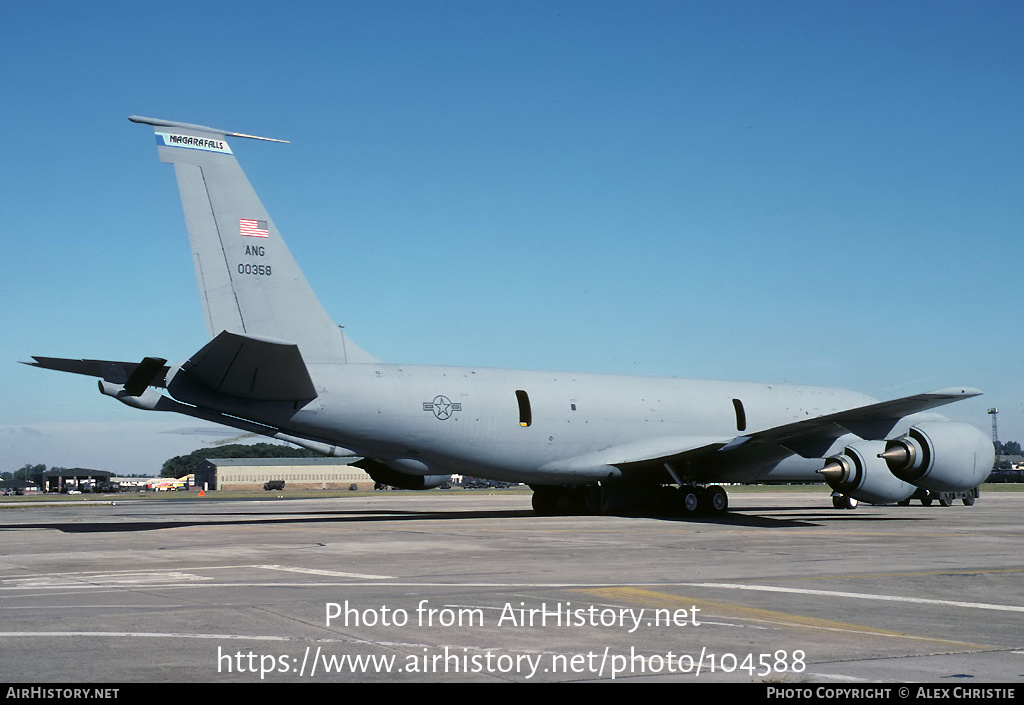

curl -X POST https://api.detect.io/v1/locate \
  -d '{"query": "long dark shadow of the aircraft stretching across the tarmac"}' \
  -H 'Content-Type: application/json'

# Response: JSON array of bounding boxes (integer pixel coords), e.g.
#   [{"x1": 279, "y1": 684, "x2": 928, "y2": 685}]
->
[{"x1": 0, "y1": 507, "x2": 927, "y2": 534}]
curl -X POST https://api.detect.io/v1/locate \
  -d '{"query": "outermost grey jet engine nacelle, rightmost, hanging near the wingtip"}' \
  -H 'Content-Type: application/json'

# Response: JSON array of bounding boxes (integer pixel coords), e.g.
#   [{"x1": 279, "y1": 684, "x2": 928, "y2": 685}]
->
[{"x1": 882, "y1": 421, "x2": 995, "y2": 492}]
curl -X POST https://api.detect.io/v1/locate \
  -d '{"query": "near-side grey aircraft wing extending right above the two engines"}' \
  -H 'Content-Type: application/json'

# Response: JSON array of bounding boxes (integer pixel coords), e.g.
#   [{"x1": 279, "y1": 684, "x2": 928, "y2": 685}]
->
[{"x1": 608, "y1": 387, "x2": 981, "y2": 472}]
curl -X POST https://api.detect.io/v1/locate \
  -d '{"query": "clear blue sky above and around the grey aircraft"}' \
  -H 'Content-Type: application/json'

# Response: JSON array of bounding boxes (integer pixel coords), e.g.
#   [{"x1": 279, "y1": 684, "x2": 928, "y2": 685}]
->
[{"x1": 0, "y1": 0, "x2": 1024, "y2": 472}]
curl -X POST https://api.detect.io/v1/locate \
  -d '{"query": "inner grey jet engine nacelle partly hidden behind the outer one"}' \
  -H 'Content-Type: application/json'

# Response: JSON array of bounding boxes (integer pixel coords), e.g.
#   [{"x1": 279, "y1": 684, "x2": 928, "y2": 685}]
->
[{"x1": 818, "y1": 441, "x2": 916, "y2": 504}]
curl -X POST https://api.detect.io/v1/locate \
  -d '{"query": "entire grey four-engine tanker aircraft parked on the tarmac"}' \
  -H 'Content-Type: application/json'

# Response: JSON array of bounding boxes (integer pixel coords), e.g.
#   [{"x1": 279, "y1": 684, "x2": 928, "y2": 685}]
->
[{"x1": 30, "y1": 117, "x2": 993, "y2": 514}]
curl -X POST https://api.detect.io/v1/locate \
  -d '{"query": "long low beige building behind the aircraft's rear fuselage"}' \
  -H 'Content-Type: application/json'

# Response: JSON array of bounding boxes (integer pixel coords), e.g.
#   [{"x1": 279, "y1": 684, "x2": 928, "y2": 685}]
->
[{"x1": 196, "y1": 458, "x2": 374, "y2": 490}]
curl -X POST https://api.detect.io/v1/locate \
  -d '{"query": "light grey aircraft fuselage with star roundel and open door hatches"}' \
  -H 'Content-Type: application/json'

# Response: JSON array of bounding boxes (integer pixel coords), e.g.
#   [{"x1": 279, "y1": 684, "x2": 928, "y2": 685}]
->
[{"x1": 169, "y1": 363, "x2": 874, "y2": 484}]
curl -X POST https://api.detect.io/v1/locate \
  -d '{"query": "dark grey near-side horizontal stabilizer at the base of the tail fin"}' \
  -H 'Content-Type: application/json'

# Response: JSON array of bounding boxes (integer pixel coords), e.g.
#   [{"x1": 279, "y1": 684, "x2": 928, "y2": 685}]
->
[{"x1": 181, "y1": 331, "x2": 316, "y2": 402}]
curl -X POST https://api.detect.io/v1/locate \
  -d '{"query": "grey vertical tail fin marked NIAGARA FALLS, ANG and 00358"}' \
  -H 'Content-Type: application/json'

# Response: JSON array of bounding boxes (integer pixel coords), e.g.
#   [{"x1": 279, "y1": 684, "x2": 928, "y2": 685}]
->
[{"x1": 129, "y1": 116, "x2": 374, "y2": 363}]
